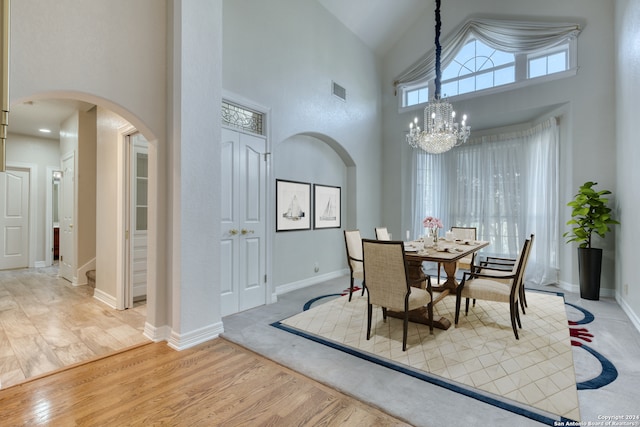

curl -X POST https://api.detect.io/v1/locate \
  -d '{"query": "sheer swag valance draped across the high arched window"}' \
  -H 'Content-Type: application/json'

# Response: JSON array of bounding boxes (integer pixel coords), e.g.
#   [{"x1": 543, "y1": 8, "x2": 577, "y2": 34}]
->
[{"x1": 394, "y1": 18, "x2": 580, "y2": 87}]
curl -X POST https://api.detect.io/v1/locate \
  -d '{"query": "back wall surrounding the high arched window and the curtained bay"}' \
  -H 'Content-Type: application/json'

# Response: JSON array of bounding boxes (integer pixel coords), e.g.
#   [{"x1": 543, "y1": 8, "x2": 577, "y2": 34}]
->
[{"x1": 382, "y1": 0, "x2": 616, "y2": 296}]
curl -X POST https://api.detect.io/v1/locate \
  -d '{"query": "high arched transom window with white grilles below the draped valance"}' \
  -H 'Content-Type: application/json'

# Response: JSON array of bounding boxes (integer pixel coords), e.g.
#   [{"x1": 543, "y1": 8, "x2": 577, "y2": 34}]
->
[{"x1": 401, "y1": 38, "x2": 576, "y2": 107}]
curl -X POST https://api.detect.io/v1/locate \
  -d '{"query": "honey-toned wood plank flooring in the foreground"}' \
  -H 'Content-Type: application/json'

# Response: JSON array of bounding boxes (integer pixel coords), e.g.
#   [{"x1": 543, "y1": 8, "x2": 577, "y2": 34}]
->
[{"x1": 0, "y1": 338, "x2": 408, "y2": 426}]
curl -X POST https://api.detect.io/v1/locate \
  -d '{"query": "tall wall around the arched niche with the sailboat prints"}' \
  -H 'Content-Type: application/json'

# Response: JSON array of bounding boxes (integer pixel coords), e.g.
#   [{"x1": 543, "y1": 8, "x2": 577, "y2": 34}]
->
[{"x1": 223, "y1": 0, "x2": 382, "y2": 287}]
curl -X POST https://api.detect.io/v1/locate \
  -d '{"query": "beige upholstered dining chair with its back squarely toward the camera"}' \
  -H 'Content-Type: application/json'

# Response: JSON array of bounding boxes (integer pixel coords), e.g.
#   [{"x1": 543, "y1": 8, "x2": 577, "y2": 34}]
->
[{"x1": 362, "y1": 239, "x2": 433, "y2": 351}]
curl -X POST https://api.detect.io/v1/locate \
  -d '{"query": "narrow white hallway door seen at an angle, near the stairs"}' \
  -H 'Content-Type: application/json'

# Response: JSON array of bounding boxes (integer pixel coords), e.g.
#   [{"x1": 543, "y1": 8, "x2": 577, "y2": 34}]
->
[{"x1": 59, "y1": 152, "x2": 76, "y2": 283}]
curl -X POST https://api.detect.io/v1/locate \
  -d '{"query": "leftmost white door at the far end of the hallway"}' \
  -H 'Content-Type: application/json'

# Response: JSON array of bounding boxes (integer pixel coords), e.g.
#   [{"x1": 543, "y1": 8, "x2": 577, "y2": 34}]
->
[{"x1": 0, "y1": 169, "x2": 29, "y2": 270}]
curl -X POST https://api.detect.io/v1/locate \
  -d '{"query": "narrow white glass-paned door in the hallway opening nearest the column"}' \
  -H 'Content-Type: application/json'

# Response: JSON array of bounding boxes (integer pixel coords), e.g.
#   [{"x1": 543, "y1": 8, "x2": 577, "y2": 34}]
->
[{"x1": 129, "y1": 133, "x2": 149, "y2": 306}]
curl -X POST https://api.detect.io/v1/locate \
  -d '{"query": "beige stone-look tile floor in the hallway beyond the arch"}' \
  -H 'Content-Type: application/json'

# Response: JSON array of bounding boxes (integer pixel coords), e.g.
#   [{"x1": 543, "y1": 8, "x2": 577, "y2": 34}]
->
[{"x1": 0, "y1": 267, "x2": 149, "y2": 388}]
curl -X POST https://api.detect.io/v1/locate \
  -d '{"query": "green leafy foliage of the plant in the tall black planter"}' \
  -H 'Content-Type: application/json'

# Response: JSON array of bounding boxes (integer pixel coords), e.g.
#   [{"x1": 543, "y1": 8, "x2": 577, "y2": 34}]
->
[{"x1": 563, "y1": 181, "x2": 620, "y2": 248}]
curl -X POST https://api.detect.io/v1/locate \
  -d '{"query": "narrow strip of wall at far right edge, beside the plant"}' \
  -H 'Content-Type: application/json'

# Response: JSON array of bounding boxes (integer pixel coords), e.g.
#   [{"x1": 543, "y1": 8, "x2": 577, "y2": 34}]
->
[{"x1": 614, "y1": 0, "x2": 640, "y2": 329}]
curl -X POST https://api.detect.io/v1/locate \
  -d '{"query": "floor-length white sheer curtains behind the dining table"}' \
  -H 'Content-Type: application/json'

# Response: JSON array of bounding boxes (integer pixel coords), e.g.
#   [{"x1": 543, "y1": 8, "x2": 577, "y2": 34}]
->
[{"x1": 413, "y1": 118, "x2": 560, "y2": 284}]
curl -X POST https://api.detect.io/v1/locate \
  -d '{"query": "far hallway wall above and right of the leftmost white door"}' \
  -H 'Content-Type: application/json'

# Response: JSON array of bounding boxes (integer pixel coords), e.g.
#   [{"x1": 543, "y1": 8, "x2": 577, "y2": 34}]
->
[{"x1": 6, "y1": 133, "x2": 60, "y2": 263}]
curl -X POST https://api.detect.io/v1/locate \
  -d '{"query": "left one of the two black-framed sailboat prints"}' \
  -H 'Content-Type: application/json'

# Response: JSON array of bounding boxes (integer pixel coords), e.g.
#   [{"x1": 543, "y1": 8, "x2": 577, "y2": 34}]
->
[{"x1": 276, "y1": 179, "x2": 311, "y2": 231}]
